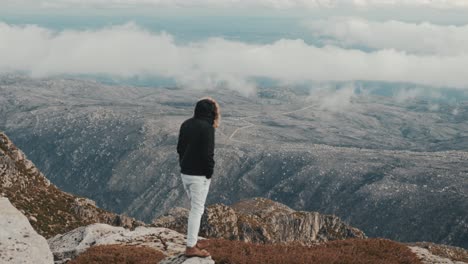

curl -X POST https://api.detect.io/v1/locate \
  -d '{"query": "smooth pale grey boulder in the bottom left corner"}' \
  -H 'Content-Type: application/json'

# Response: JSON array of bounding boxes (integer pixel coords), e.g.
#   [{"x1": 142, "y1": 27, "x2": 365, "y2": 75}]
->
[{"x1": 0, "y1": 198, "x2": 53, "y2": 264}]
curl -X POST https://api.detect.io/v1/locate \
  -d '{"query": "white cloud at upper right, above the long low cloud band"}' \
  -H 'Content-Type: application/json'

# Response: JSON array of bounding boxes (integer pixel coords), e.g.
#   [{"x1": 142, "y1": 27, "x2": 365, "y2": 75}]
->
[{"x1": 304, "y1": 17, "x2": 468, "y2": 55}]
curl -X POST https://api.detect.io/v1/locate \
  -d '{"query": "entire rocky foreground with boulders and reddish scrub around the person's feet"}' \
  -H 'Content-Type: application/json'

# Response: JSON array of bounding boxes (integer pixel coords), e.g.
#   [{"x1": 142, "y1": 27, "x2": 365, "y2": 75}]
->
[{"x1": 0, "y1": 134, "x2": 468, "y2": 264}]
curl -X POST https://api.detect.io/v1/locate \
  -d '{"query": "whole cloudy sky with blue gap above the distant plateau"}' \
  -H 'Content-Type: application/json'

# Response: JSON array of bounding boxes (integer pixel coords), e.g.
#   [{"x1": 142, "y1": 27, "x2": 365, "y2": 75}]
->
[{"x1": 0, "y1": 0, "x2": 468, "y2": 94}]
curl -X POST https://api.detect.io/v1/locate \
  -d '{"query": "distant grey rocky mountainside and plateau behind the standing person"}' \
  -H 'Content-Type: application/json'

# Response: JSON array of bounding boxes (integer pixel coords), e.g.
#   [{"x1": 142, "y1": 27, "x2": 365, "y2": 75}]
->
[{"x1": 0, "y1": 76, "x2": 468, "y2": 247}]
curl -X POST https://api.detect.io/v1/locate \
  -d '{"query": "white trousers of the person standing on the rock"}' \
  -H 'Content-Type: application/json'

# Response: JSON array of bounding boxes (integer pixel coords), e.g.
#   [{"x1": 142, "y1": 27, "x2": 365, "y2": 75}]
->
[{"x1": 181, "y1": 173, "x2": 211, "y2": 247}]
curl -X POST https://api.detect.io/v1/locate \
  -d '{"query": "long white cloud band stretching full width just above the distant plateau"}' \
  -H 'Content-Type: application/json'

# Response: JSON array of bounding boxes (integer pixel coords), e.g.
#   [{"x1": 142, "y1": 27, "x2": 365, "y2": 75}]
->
[{"x1": 0, "y1": 23, "x2": 468, "y2": 94}]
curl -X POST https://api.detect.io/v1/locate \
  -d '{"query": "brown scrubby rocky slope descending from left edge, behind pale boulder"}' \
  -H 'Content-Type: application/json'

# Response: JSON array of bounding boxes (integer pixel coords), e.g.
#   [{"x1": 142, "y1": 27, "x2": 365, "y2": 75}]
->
[{"x1": 0, "y1": 132, "x2": 143, "y2": 237}]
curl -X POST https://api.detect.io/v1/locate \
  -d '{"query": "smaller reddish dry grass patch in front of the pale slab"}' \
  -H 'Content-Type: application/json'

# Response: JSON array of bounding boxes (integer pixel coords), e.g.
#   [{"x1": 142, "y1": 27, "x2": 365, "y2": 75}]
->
[{"x1": 68, "y1": 245, "x2": 165, "y2": 264}]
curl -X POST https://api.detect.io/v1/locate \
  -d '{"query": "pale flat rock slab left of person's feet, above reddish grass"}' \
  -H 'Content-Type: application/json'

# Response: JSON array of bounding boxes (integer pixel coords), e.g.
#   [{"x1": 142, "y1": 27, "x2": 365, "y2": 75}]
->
[{"x1": 48, "y1": 224, "x2": 209, "y2": 263}]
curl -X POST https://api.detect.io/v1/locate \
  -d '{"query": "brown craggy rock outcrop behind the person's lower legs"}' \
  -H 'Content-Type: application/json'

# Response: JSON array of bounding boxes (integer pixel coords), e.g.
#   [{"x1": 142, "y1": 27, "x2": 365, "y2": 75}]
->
[{"x1": 153, "y1": 198, "x2": 366, "y2": 245}]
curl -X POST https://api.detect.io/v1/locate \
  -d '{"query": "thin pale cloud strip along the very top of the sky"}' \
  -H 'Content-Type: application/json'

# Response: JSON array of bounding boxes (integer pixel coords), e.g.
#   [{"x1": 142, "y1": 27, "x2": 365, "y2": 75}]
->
[{"x1": 3, "y1": 0, "x2": 468, "y2": 9}]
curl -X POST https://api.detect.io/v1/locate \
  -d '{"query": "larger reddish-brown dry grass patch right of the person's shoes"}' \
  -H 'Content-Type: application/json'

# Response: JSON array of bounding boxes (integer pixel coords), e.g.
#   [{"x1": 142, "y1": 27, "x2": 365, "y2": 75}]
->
[{"x1": 204, "y1": 239, "x2": 421, "y2": 264}]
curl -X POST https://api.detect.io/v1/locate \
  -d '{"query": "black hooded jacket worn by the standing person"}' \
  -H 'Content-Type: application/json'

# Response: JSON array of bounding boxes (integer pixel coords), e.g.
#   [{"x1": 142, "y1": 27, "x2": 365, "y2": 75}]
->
[{"x1": 177, "y1": 100, "x2": 215, "y2": 179}]
